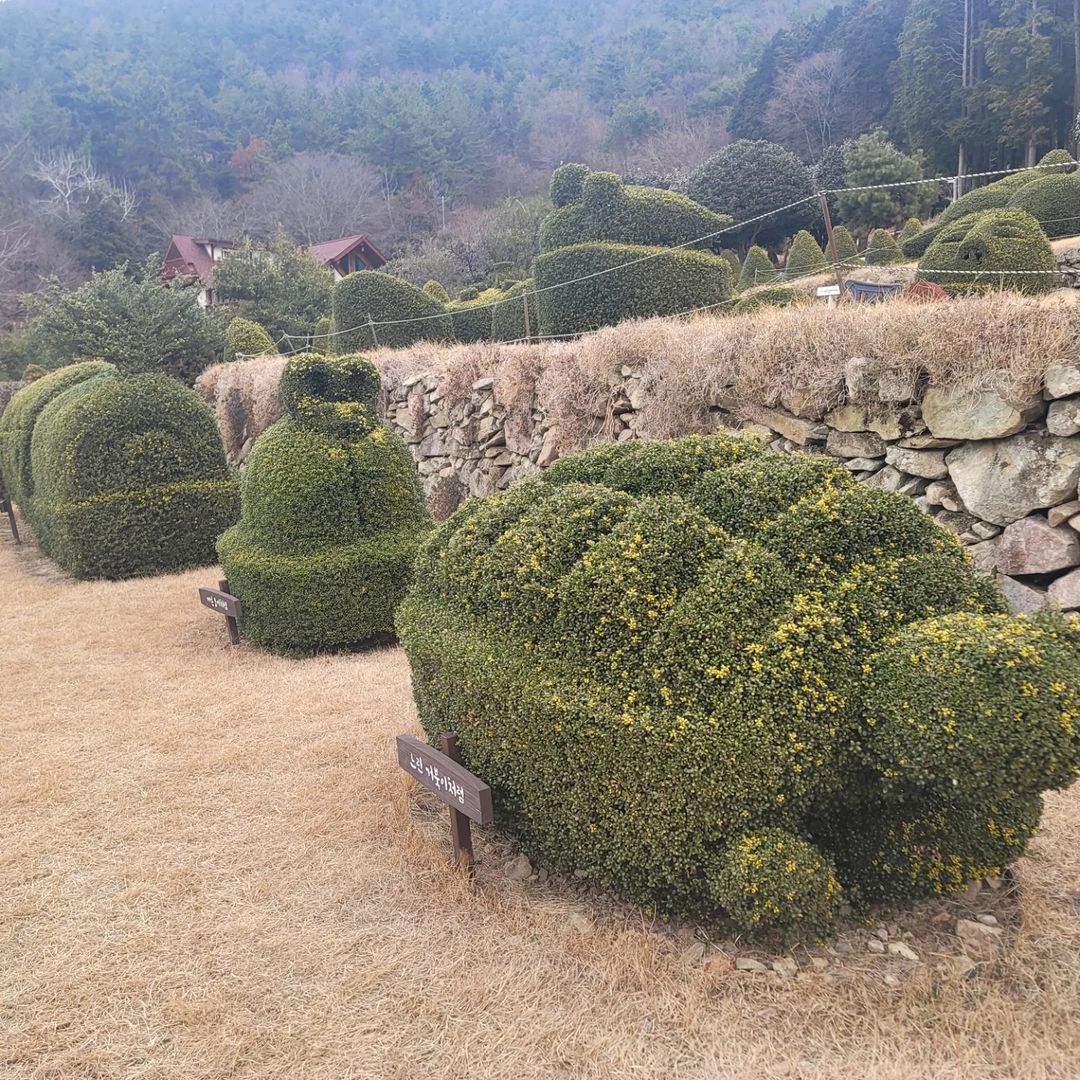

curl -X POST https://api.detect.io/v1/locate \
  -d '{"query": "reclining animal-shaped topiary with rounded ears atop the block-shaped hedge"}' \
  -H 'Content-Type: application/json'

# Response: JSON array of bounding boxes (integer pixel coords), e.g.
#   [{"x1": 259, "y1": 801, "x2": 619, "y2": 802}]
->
[{"x1": 540, "y1": 165, "x2": 731, "y2": 252}]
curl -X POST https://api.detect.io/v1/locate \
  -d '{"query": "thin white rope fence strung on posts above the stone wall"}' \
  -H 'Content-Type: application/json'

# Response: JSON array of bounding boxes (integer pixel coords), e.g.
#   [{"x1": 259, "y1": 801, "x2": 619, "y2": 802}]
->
[{"x1": 267, "y1": 159, "x2": 1080, "y2": 353}]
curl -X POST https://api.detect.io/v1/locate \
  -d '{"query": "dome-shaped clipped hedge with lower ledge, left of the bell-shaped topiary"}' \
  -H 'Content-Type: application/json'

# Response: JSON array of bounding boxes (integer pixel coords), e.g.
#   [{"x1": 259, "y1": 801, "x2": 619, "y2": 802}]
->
[{"x1": 24, "y1": 372, "x2": 240, "y2": 579}]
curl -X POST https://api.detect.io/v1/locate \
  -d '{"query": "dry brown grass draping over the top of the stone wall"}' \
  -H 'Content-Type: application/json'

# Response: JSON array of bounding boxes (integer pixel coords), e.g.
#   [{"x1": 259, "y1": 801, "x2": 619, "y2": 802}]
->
[{"x1": 200, "y1": 294, "x2": 1080, "y2": 455}]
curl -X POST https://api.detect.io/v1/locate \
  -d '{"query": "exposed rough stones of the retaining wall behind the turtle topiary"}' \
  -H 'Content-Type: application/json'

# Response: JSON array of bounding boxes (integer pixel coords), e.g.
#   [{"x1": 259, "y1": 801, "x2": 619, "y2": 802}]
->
[{"x1": 386, "y1": 359, "x2": 1080, "y2": 611}]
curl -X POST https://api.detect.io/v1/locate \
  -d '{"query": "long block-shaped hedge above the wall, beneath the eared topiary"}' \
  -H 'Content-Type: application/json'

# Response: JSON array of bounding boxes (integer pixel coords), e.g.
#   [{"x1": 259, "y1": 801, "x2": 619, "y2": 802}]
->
[{"x1": 533, "y1": 244, "x2": 731, "y2": 335}]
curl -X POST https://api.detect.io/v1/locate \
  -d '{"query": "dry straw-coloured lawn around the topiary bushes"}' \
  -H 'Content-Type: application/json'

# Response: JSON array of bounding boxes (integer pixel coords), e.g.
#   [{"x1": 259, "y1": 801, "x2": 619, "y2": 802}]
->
[{"x1": 0, "y1": 533, "x2": 1080, "y2": 1080}]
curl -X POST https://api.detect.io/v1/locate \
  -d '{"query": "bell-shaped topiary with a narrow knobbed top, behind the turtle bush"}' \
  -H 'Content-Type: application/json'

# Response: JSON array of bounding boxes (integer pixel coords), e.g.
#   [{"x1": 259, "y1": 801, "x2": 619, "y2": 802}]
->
[{"x1": 218, "y1": 355, "x2": 430, "y2": 653}]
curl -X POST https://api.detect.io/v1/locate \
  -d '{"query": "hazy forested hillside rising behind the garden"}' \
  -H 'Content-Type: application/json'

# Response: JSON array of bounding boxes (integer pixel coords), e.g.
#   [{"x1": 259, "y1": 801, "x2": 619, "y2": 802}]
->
[{"x1": 0, "y1": 0, "x2": 1080, "y2": 326}]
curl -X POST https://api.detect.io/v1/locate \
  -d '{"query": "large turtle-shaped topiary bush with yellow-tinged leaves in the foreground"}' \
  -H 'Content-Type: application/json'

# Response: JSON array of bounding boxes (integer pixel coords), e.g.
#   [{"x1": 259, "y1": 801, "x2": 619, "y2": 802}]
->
[{"x1": 397, "y1": 436, "x2": 1080, "y2": 932}]
